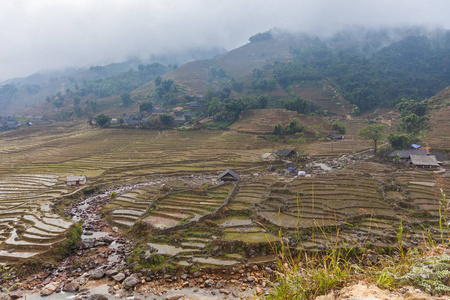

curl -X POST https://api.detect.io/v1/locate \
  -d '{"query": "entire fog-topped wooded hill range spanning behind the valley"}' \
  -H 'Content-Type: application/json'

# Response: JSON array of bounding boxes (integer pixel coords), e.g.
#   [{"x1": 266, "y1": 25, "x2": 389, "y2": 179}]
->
[{"x1": 0, "y1": 28, "x2": 450, "y2": 119}]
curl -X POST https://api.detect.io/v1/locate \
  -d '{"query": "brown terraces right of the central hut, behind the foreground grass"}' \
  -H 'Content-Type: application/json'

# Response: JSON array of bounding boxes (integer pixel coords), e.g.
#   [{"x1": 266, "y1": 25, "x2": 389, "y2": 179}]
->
[{"x1": 253, "y1": 163, "x2": 450, "y2": 248}]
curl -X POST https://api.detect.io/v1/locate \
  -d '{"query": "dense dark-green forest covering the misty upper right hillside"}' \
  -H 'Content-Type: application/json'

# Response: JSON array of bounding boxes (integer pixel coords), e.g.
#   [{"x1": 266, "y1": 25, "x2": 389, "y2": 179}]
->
[{"x1": 274, "y1": 35, "x2": 450, "y2": 112}]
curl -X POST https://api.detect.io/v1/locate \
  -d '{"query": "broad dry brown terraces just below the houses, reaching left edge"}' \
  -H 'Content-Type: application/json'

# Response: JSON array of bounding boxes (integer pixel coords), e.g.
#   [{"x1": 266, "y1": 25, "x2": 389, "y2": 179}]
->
[{"x1": 0, "y1": 125, "x2": 278, "y2": 183}]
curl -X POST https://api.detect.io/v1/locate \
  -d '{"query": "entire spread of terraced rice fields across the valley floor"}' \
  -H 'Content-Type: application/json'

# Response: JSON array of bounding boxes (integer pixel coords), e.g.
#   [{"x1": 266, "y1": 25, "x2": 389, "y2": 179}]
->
[{"x1": 0, "y1": 120, "x2": 450, "y2": 264}]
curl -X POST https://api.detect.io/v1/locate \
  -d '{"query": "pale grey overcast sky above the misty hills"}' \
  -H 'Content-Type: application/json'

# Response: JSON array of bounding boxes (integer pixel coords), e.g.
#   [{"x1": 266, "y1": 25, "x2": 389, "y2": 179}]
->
[{"x1": 0, "y1": 0, "x2": 450, "y2": 80}]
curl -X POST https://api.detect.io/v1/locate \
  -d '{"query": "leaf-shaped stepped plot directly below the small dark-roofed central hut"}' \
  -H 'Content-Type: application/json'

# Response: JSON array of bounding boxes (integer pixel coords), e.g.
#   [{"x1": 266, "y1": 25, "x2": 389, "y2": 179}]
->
[{"x1": 144, "y1": 184, "x2": 234, "y2": 229}]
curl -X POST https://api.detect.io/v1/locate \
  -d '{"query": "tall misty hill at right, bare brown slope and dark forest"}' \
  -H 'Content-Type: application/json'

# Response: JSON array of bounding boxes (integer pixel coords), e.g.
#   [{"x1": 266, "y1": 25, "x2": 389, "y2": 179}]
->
[{"x1": 135, "y1": 29, "x2": 450, "y2": 115}]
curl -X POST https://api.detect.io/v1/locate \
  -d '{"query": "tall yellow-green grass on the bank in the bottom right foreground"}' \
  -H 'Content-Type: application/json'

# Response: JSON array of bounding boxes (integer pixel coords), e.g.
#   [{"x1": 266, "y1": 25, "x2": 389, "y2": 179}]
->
[{"x1": 264, "y1": 189, "x2": 450, "y2": 300}]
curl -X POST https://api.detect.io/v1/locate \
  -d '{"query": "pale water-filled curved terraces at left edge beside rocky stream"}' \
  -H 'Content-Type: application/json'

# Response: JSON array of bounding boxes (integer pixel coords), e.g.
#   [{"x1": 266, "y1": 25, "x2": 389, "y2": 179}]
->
[{"x1": 0, "y1": 174, "x2": 72, "y2": 263}]
